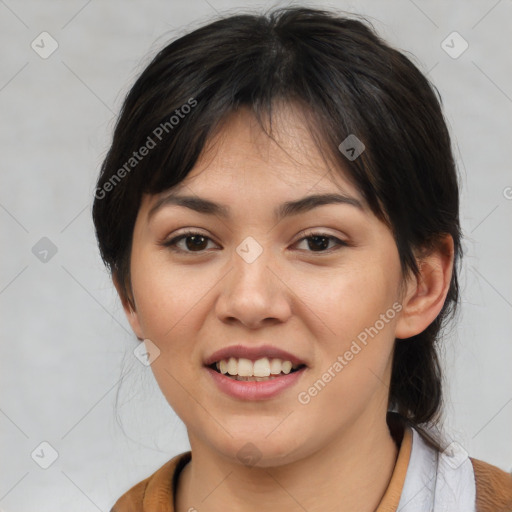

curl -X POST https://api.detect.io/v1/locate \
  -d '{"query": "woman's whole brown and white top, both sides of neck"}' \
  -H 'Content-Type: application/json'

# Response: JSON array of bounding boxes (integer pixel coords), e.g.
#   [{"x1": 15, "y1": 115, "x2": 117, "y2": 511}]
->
[{"x1": 111, "y1": 426, "x2": 512, "y2": 512}]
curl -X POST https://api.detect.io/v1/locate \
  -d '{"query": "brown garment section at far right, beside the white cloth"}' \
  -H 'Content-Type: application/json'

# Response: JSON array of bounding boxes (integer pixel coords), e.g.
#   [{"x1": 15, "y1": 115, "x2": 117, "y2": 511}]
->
[{"x1": 469, "y1": 457, "x2": 512, "y2": 512}]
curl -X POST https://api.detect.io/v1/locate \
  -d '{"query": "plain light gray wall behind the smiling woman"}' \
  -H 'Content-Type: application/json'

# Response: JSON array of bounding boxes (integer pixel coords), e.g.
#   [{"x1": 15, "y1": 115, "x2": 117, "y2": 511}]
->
[{"x1": 0, "y1": 0, "x2": 512, "y2": 512}]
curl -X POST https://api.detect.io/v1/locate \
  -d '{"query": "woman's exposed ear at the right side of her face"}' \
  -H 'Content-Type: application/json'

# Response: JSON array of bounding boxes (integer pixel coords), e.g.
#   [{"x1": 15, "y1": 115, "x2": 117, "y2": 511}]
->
[{"x1": 395, "y1": 235, "x2": 454, "y2": 339}]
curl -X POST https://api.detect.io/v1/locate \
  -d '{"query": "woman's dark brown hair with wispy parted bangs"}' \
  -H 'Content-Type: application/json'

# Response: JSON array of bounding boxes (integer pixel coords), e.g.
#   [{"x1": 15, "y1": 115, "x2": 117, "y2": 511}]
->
[{"x1": 93, "y1": 8, "x2": 461, "y2": 442}]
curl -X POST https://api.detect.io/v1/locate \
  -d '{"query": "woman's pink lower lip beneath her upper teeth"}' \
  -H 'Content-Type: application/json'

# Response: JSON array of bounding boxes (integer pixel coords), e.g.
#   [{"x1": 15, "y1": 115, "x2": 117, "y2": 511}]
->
[{"x1": 206, "y1": 367, "x2": 306, "y2": 400}]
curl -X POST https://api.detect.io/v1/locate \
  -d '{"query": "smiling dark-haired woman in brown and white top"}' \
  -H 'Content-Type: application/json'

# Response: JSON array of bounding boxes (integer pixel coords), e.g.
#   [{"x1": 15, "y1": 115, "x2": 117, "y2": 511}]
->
[{"x1": 93, "y1": 8, "x2": 512, "y2": 512}]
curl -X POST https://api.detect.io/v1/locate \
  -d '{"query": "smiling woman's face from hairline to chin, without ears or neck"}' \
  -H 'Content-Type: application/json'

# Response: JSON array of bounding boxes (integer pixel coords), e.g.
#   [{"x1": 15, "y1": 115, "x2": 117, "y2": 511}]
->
[{"x1": 123, "y1": 108, "x2": 408, "y2": 466}]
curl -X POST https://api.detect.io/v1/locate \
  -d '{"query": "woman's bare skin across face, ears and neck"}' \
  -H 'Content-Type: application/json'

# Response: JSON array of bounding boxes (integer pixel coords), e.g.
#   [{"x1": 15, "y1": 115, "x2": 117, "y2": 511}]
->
[{"x1": 117, "y1": 107, "x2": 453, "y2": 512}]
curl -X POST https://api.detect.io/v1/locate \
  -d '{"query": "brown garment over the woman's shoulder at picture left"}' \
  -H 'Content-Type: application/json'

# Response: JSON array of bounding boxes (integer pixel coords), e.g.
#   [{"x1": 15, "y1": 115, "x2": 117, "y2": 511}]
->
[{"x1": 110, "y1": 451, "x2": 191, "y2": 512}]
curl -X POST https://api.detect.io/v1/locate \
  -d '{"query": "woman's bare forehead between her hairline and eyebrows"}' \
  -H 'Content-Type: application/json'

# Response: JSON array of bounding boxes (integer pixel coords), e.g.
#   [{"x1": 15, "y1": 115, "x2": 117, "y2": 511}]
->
[{"x1": 168, "y1": 105, "x2": 362, "y2": 201}]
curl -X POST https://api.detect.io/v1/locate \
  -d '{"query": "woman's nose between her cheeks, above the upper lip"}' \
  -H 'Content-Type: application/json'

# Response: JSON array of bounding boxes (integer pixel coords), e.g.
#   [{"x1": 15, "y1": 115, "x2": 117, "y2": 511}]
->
[{"x1": 215, "y1": 243, "x2": 292, "y2": 329}]
